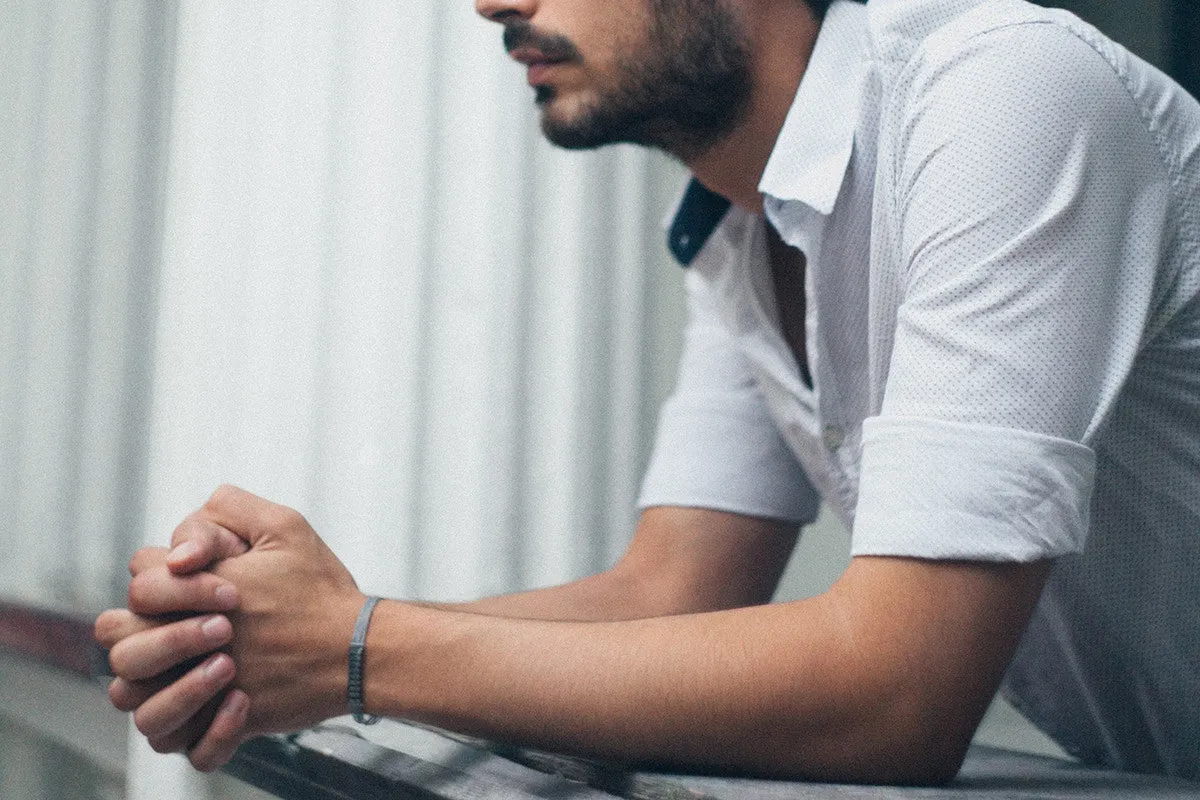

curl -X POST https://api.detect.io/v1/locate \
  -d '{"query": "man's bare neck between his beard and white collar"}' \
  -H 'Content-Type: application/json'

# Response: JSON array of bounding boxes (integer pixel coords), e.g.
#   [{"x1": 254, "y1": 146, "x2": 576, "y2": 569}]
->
[{"x1": 686, "y1": 0, "x2": 820, "y2": 213}]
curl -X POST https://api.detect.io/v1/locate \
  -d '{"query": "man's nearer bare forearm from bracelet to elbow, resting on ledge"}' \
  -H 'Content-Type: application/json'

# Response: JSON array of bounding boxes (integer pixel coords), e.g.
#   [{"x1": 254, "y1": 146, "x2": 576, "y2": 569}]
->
[{"x1": 348, "y1": 556, "x2": 1038, "y2": 782}]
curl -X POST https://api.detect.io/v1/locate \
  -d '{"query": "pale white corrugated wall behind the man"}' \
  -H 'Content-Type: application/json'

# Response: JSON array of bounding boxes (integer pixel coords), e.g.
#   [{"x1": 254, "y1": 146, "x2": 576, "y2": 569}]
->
[{"x1": 0, "y1": 0, "x2": 682, "y2": 798}]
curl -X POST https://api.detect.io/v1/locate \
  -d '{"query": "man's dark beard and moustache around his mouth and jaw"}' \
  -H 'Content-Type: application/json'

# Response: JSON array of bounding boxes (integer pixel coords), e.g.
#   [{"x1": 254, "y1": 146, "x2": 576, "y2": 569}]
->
[{"x1": 505, "y1": 0, "x2": 752, "y2": 161}]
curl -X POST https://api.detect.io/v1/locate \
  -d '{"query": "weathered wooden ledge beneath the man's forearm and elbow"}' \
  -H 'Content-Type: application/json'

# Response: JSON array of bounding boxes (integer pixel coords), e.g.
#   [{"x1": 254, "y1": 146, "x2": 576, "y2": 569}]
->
[{"x1": 228, "y1": 721, "x2": 1200, "y2": 800}]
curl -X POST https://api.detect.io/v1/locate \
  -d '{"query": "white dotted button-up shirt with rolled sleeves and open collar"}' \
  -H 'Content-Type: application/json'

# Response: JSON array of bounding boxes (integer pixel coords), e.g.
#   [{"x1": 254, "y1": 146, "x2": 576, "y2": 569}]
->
[{"x1": 641, "y1": 0, "x2": 1200, "y2": 778}]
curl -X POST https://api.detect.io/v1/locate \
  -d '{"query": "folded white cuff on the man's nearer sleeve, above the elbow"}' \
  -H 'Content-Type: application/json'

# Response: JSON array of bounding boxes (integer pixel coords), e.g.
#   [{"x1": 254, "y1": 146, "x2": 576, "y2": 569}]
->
[{"x1": 852, "y1": 416, "x2": 1096, "y2": 561}]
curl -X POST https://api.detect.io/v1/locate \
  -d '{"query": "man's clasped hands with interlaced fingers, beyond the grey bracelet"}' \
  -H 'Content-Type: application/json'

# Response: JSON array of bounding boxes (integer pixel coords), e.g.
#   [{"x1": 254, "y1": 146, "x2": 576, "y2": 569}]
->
[{"x1": 96, "y1": 486, "x2": 364, "y2": 771}]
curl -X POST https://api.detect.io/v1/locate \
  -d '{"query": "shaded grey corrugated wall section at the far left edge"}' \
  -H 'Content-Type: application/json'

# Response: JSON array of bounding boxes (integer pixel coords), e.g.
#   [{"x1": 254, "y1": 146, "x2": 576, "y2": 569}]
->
[{"x1": 0, "y1": 1, "x2": 173, "y2": 608}]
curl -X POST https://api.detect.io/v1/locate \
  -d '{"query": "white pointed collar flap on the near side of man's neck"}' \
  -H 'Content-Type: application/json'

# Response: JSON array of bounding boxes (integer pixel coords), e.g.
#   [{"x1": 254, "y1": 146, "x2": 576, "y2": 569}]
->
[{"x1": 758, "y1": 0, "x2": 870, "y2": 215}]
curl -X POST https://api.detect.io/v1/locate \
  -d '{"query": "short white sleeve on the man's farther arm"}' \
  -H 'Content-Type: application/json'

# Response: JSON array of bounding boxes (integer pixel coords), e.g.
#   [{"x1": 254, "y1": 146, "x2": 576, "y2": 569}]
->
[{"x1": 638, "y1": 272, "x2": 820, "y2": 524}]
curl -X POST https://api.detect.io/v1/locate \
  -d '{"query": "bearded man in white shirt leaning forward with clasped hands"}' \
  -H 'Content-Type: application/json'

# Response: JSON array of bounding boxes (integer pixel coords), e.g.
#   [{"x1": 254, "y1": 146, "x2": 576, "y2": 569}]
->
[{"x1": 96, "y1": 0, "x2": 1200, "y2": 783}]
